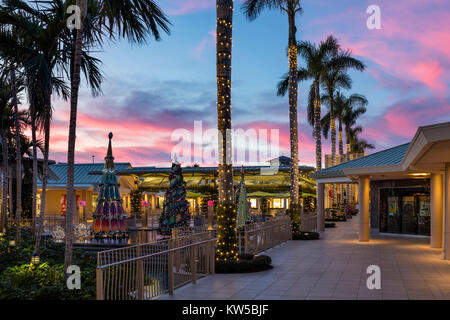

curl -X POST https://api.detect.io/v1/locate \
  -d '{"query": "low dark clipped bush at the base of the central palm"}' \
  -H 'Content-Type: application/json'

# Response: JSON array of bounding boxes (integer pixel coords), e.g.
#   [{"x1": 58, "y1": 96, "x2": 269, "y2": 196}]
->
[{"x1": 215, "y1": 254, "x2": 273, "y2": 273}]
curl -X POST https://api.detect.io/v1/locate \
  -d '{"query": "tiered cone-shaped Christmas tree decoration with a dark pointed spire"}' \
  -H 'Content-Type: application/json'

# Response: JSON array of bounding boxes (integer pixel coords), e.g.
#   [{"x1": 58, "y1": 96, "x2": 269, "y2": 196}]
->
[{"x1": 93, "y1": 133, "x2": 128, "y2": 239}]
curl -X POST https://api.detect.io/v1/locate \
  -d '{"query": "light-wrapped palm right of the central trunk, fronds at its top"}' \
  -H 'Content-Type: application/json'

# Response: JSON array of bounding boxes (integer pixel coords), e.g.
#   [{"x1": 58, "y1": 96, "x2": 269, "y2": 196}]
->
[{"x1": 242, "y1": 0, "x2": 302, "y2": 206}]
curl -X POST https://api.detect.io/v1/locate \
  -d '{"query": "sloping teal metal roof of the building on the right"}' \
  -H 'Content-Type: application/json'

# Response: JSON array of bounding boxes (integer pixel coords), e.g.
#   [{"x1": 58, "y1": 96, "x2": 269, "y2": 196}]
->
[{"x1": 311, "y1": 143, "x2": 410, "y2": 179}]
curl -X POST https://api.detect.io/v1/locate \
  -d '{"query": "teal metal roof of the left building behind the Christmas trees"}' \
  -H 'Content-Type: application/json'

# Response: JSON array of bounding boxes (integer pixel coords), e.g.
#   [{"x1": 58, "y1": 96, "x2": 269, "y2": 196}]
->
[{"x1": 38, "y1": 163, "x2": 131, "y2": 187}]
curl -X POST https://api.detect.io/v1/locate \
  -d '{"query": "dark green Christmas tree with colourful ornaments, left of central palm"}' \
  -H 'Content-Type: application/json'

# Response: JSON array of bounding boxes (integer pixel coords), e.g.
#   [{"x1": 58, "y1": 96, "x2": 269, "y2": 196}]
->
[{"x1": 158, "y1": 160, "x2": 190, "y2": 235}]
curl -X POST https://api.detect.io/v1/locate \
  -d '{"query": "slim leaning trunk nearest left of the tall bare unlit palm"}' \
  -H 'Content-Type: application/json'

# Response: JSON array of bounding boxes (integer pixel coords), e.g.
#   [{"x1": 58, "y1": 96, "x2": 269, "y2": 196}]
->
[{"x1": 34, "y1": 112, "x2": 51, "y2": 255}]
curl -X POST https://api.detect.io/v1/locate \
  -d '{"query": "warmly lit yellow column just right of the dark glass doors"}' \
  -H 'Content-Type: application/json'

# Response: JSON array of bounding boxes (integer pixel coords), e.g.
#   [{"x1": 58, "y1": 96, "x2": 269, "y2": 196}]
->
[{"x1": 430, "y1": 174, "x2": 443, "y2": 248}]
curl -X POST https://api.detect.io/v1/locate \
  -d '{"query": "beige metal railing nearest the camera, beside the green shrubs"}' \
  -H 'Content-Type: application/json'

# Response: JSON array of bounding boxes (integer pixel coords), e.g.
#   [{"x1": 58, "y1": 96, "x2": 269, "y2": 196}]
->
[{"x1": 96, "y1": 237, "x2": 217, "y2": 300}]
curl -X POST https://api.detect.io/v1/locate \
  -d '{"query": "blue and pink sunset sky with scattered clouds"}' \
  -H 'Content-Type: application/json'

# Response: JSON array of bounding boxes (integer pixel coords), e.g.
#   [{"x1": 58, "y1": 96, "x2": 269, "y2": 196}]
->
[{"x1": 44, "y1": 0, "x2": 450, "y2": 166}]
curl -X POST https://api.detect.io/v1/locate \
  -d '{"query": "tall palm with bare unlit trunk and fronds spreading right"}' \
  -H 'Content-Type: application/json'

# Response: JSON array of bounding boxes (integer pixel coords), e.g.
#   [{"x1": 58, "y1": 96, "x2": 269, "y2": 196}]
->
[{"x1": 64, "y1": 0, "x2": 170, "y2": 276}]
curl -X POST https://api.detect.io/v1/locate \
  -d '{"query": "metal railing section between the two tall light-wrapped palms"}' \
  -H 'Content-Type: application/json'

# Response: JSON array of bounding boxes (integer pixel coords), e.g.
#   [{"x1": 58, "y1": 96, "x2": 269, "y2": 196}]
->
[{"x1": 237, "y1": 216, "x2": 292, "y2": 254}]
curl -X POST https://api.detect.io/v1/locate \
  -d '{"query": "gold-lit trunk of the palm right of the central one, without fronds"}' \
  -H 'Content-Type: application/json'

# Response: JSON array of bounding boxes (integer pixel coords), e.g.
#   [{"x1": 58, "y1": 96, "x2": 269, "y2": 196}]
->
[{"x1": 288, "y1": 12, "x2": 300, "y2": 205}]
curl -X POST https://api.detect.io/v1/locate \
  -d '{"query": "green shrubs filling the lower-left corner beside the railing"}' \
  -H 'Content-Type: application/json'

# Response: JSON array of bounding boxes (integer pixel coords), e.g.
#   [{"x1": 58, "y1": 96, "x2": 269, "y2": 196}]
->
[{"x1": 0, "y1": 229, "x2": 97, "y2": 300}]
